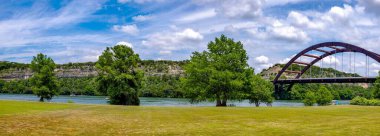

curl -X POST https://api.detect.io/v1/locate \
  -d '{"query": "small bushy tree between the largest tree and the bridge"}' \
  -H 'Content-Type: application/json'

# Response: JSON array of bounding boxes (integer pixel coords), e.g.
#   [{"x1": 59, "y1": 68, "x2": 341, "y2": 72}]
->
[{"x1": 248, "y1": 75, "x2": 274, "y2": 107}]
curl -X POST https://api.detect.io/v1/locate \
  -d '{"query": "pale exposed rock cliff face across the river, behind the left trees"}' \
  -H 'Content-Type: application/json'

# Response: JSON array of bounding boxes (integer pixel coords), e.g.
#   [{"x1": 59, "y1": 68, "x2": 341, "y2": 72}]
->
[{"x1": 0, "y1": 61, "x2": 184, "y2": 81}]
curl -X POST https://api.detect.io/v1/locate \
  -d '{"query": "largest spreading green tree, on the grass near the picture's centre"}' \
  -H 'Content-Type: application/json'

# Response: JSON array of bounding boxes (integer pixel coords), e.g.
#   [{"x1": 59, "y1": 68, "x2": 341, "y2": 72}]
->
[{"x1": 181, "y1": 35, "x2": 253, "y2": 106}]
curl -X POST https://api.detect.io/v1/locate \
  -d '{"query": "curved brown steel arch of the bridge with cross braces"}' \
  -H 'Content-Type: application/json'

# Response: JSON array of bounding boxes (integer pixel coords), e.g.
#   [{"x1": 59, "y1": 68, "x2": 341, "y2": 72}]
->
[{"x1": 273, "y1": 42, "x2": 380, "y2": 84}]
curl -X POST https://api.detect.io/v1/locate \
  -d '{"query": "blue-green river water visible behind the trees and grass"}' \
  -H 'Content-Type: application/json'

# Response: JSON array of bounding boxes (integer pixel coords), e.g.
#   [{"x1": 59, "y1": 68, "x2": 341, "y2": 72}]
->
[{"x1": 0, "y1": 93, "x2": 349, "y2": 107}]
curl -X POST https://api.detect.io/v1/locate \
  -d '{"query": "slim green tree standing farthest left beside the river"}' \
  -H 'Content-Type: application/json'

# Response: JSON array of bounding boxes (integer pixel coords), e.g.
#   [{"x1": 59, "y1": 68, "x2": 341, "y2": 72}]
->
[{"x1": 30, "y1": 53, "x2": 58, "y2": 102}]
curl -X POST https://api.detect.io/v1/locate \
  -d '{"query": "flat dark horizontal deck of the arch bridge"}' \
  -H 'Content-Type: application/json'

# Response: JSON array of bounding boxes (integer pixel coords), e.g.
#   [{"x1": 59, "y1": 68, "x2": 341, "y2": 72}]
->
[{"x1": 276, "y1": 77, "x2": 376, "y2": 84}]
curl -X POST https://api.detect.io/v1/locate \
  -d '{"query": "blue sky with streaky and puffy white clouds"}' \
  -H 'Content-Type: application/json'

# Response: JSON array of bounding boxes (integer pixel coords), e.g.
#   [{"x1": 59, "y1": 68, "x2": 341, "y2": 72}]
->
[{"x1": 0, "y1": 0, "x2": 380, "y2": 75}]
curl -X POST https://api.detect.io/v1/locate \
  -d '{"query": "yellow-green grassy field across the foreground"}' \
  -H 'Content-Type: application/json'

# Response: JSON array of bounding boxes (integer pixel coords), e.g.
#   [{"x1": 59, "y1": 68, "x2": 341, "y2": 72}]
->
[{"x1": 0, "y1": 100, "x2": 380, "y2": 136}]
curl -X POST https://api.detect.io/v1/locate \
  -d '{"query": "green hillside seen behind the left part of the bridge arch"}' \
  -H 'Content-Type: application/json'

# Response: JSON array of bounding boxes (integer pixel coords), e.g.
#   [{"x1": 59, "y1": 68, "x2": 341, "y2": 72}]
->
[{"x1": 260, "y1": 64, "x2": 360, "y2": 80}]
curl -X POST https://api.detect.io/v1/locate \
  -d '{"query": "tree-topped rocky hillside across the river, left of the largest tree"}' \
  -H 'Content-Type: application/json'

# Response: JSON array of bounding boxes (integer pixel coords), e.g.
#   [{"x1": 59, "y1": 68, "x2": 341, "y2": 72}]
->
[{"x1": 0, "y1": 60, "x2": 187, "y2": 80}]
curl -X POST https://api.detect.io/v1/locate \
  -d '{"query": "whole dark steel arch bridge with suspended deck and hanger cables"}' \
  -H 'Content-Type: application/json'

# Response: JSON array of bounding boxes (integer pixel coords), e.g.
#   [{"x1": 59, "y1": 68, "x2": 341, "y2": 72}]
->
[{"x1": 272, "y1": 42, "x2": 380, "y2": 92}]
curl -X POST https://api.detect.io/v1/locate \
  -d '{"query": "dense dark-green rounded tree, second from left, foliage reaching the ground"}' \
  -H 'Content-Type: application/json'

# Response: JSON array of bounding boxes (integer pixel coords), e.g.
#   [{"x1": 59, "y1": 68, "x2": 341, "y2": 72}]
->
[{"x1": 96, "y1": 45, "x2": 143, "y2": 105}]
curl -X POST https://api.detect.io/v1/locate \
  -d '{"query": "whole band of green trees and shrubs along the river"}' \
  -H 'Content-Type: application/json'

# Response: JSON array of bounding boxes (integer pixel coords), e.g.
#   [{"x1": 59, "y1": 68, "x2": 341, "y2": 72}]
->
[{"x1": 0, "y1": 35, "x2": 376, "y2": 106}]
